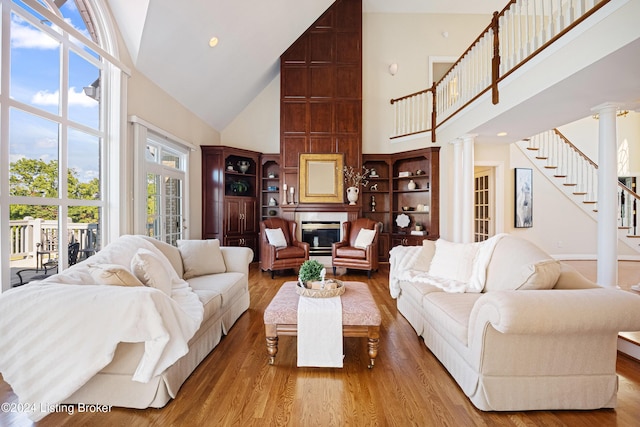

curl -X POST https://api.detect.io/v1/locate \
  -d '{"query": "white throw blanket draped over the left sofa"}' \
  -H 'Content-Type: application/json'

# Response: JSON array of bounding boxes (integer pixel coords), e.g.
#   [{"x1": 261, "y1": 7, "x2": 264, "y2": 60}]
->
[{"x1": 0, "y1": 236, "x2": 204, "y2": 421}]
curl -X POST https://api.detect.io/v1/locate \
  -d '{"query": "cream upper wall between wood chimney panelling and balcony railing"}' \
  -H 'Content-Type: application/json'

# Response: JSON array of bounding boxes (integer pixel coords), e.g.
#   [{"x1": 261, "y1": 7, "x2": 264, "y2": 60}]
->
[{"x1": 362, "y1": 13, "x2": 491, "y2": 153}]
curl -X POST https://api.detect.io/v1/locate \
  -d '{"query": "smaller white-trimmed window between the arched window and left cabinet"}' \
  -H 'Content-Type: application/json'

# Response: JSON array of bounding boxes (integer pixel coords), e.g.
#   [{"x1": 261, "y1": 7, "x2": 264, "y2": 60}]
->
[{"x1": 130, "y1": 117, "x2": 194, "y2": 246}]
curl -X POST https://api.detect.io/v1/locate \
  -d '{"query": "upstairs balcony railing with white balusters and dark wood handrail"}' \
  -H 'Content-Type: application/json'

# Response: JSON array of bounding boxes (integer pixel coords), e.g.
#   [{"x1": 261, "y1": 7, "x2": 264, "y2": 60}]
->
[{"x1": 391, "y1": 0, "x2": 610, "y2": 142}]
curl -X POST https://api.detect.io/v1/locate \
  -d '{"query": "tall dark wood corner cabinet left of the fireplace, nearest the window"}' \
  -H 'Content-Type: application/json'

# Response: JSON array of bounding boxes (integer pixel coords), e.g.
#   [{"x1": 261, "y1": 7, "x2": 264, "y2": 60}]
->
[{"x1": 202, "y1": 146, "x2": 261, "y2": 260}]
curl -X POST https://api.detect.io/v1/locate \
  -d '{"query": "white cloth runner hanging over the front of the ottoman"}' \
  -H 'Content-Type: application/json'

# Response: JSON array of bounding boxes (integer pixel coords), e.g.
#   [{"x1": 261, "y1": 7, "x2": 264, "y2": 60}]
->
[{"x1": 298, "y1": 296, "x2": 344, "y2": 368}]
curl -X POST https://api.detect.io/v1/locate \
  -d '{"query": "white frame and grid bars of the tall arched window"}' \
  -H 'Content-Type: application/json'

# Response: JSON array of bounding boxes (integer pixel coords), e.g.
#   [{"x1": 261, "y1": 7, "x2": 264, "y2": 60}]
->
[{"x1": 0, "y1": 0, "x2": 131, "y2": 291}]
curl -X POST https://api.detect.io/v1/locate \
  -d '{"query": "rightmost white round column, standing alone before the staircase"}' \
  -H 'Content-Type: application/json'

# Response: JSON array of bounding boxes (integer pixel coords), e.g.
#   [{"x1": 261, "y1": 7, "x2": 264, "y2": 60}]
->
[{"x1": 593, "y1": 104, "x2": 618, "y2": 287}]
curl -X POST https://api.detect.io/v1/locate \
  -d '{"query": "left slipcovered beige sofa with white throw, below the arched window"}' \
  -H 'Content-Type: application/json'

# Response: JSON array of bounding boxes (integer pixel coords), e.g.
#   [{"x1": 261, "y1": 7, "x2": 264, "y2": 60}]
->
[{"x1": 0, "y1": 236, "x2": 253, "y2": 420}]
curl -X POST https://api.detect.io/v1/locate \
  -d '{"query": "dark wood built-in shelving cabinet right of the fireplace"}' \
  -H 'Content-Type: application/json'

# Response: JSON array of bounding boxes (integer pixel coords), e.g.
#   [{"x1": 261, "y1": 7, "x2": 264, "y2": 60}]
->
[{"x1": 361, "y1": 147, "x2": 440, "y2": 254}]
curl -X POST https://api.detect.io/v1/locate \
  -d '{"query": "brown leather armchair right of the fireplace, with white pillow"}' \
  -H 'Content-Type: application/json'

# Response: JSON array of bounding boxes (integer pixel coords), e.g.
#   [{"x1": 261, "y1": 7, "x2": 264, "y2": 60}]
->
[{"x1": 331, "y1": 218, "x2": 380, "y2": 278}]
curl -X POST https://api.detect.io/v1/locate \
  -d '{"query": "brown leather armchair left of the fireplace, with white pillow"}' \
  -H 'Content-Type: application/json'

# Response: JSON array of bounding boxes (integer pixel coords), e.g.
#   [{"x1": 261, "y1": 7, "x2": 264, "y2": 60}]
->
[{"x1": 260, "y1": 218, "x2": 309, "y2": 279}]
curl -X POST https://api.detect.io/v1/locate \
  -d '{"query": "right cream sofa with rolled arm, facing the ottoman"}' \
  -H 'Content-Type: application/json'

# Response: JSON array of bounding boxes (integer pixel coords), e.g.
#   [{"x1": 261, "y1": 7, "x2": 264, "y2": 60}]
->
[{"x1": 390, "y1": 235, "x2": 640, "y2": 411}]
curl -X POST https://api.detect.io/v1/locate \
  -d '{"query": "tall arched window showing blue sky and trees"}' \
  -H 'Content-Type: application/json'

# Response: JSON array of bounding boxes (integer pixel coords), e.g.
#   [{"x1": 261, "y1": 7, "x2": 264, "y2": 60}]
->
[{"x1": 0, "y1": 0, "x2": 127, "y2": 289}]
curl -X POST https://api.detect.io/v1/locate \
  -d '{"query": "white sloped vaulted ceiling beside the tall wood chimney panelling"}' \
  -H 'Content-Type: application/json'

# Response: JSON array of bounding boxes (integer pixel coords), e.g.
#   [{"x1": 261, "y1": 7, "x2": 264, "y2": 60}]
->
[{"x1": 107, "y1": 0, "x2": 507, "y2": 131}]
